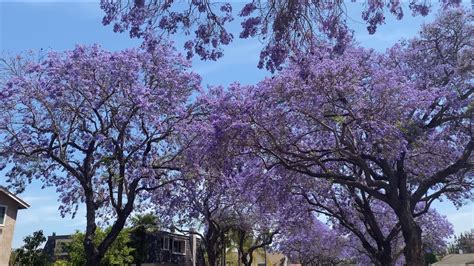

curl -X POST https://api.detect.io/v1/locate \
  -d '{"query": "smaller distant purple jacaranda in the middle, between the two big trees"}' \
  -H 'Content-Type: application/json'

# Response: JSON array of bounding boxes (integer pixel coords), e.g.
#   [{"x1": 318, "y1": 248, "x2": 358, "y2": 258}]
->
[{"x1": 151, "y1": 96, "x2": 278, "y2": 265}]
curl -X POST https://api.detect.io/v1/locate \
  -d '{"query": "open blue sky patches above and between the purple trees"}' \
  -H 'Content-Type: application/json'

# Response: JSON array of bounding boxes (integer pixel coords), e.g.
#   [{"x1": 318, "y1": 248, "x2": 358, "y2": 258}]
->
[{"x1": 0, "y1": 0, "x2": 474, "y2": 247}]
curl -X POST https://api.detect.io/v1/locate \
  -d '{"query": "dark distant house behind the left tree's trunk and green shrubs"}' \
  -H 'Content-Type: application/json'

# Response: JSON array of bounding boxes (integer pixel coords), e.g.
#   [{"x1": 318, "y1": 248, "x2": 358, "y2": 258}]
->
[{"x1": 44, "y1": 231, "x2": 205, "y2": 266}]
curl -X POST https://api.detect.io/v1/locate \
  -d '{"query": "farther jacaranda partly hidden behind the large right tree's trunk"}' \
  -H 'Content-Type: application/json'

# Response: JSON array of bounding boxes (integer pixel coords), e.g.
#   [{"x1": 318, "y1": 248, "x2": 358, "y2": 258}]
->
[{"x1": 288, "y1": 173, "x2": 453, "y2": 265}]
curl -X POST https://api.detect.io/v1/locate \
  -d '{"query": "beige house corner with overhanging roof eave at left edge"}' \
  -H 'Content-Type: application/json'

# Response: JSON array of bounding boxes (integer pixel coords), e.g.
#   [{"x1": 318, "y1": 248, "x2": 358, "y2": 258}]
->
[{"x1": 0, "y1": 186, "x2": 30, "y2": 265}]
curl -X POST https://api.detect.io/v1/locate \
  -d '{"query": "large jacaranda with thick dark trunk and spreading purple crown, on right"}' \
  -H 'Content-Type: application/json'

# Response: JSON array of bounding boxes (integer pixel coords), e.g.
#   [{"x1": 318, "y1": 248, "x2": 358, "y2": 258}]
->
[{"x1": 206, "y1": 9, "x2": 474, "y2": 265}]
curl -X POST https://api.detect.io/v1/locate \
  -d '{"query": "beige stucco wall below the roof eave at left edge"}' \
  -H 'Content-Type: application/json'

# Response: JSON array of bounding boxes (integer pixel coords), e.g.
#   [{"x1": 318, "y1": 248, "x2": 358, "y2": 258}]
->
[{"x1": 0, "y1": 192, "x2": 18, "y2": 266}]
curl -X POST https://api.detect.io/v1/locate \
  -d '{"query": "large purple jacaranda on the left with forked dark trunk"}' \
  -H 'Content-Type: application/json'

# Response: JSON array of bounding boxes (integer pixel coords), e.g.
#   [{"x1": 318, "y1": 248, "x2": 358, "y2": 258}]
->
[{"x1": 0, "y1": 42, "x2": 200, "y2": 265}]
